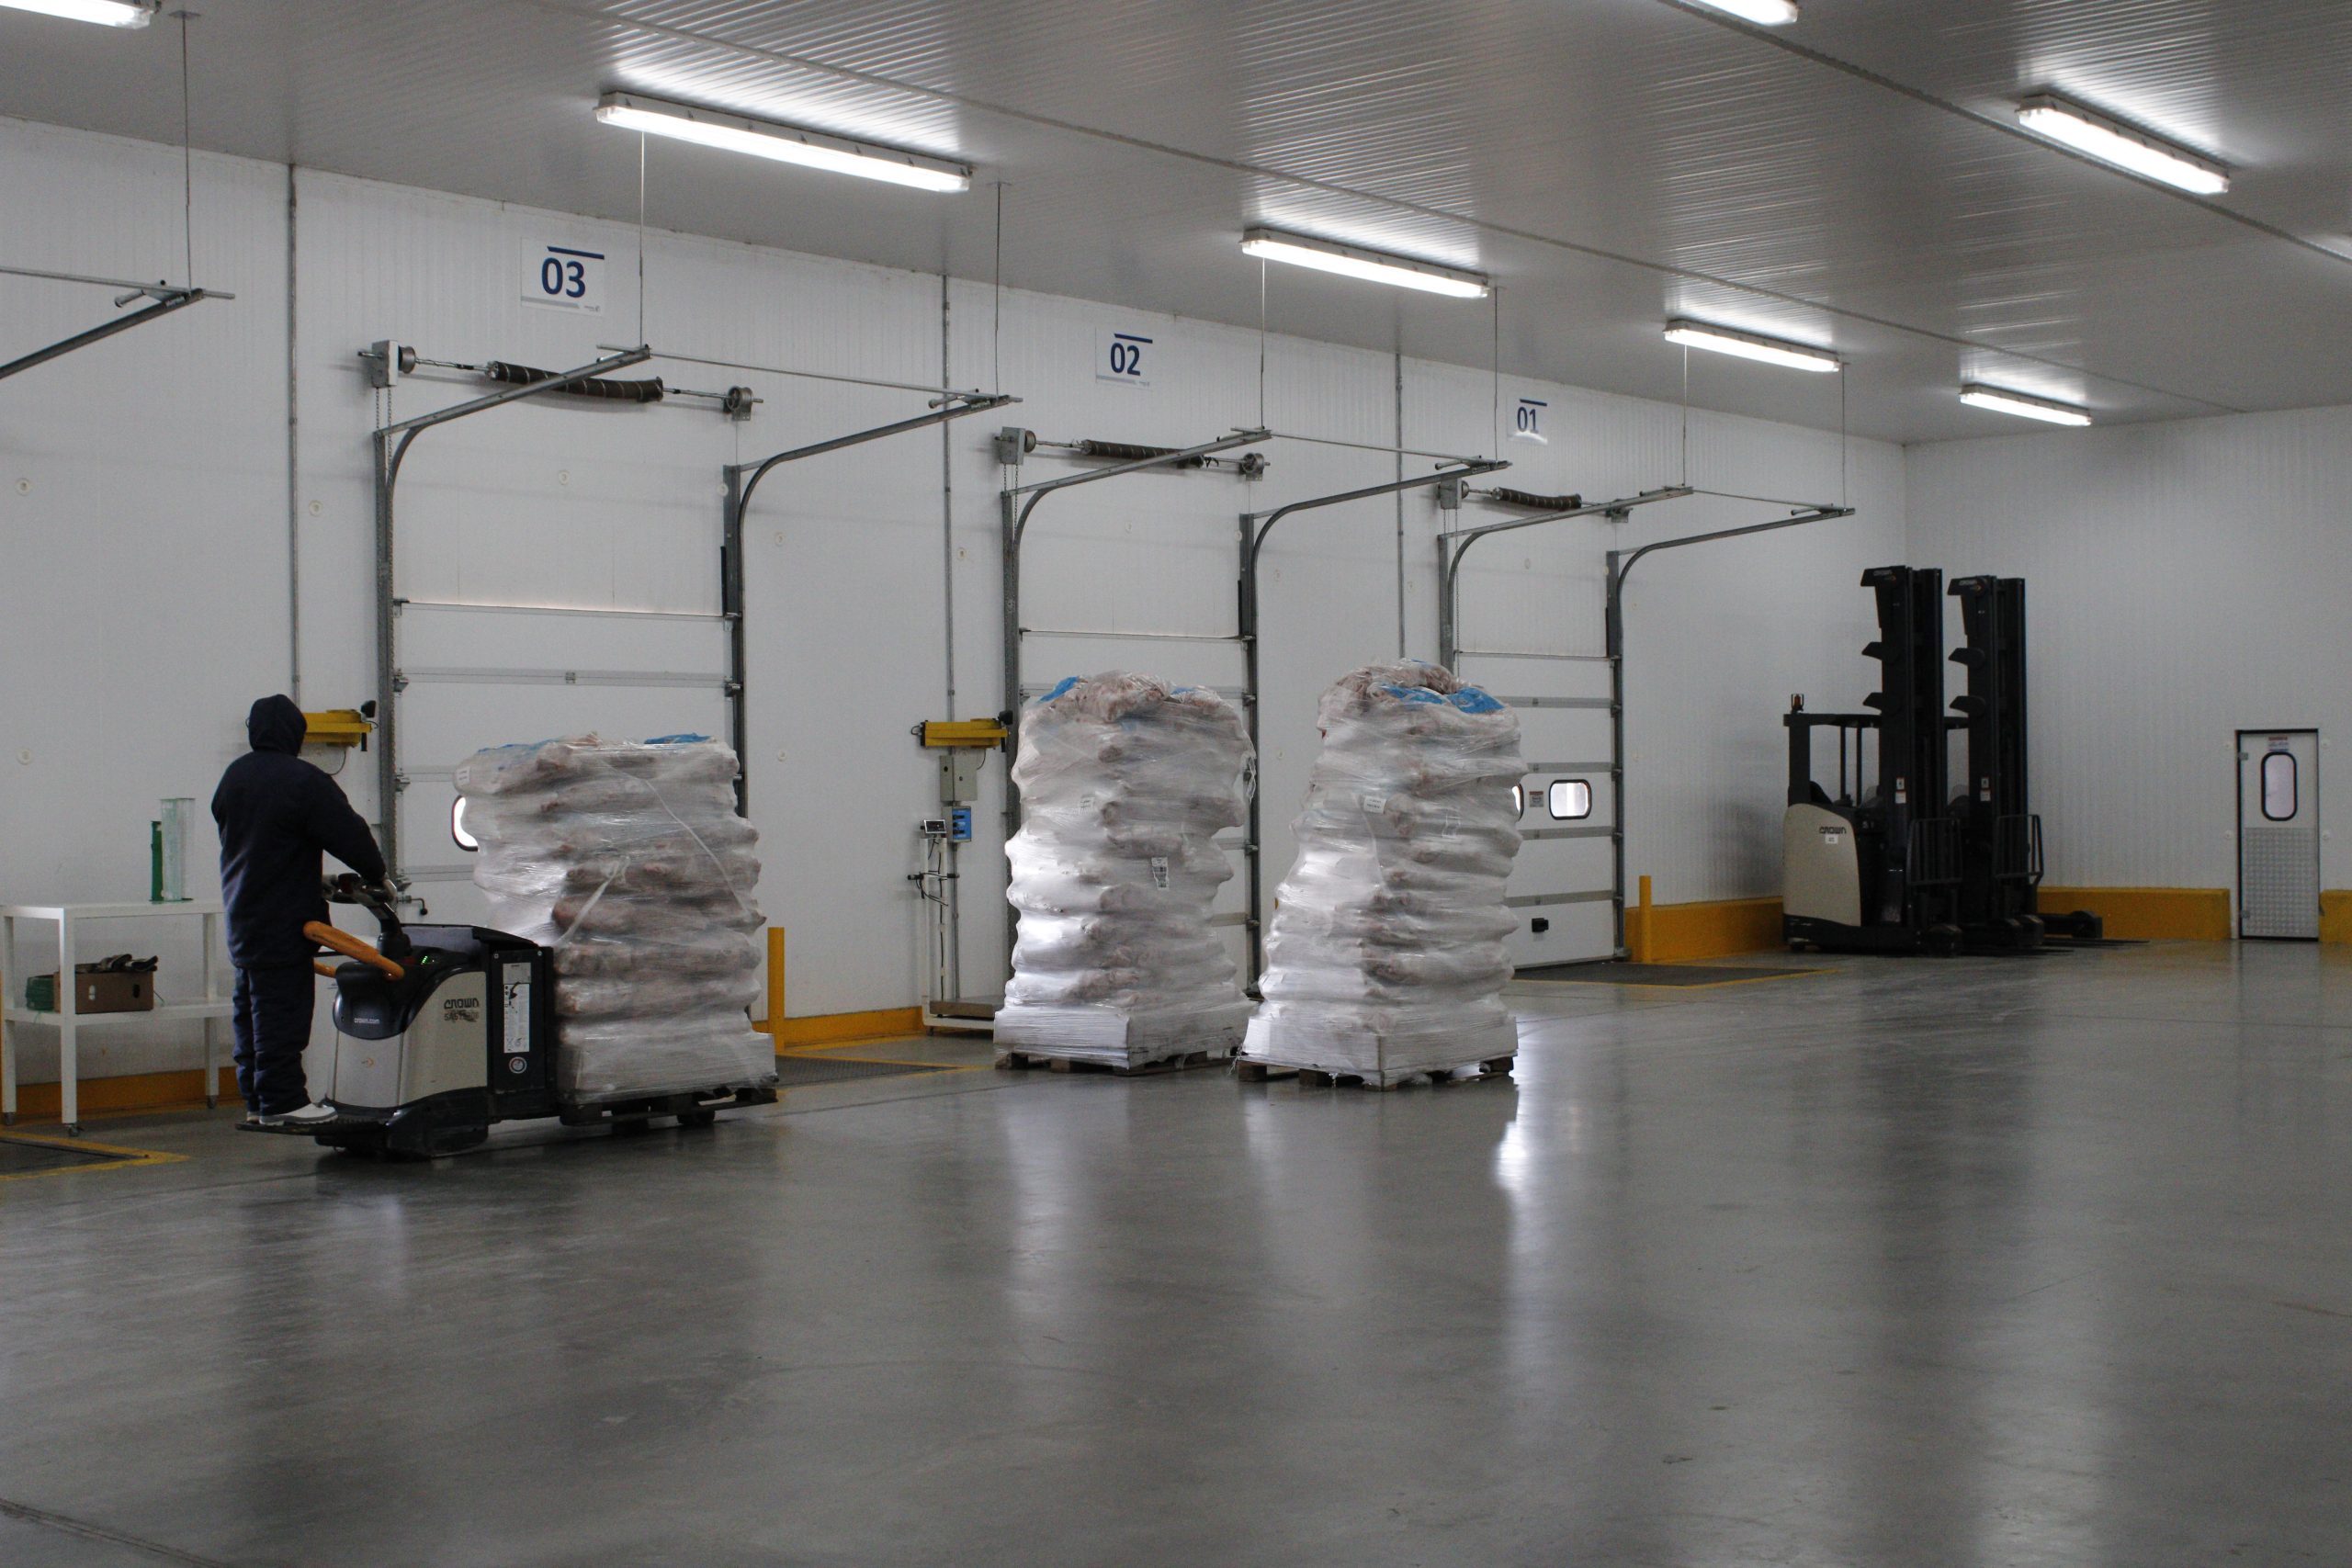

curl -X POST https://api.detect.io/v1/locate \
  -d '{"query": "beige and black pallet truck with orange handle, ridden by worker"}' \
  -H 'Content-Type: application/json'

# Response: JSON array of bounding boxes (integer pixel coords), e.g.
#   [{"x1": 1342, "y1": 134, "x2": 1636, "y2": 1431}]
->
[{"x1": 247, "y1": 874, "x2": 776, "y2": 1156}]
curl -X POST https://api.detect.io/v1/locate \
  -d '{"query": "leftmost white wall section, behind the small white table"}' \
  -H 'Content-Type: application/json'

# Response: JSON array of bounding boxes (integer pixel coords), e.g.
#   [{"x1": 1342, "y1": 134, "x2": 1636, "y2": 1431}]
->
[{"x1": 0, "y1": 120, "x2": 287, "y2": 1079}]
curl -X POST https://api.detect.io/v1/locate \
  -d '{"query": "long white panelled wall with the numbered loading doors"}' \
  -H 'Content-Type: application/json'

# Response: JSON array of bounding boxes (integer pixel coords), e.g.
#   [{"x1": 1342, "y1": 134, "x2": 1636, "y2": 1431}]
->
[{"x1": 0, "y1": 122, "x2": 1903, "y2": 1090}]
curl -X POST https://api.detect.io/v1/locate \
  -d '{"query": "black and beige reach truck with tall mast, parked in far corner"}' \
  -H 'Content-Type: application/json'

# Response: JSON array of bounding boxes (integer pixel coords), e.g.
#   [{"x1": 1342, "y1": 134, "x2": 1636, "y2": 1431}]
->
[{"x1": 1781, "y1": 567, "x2": 2100, "y2": 954}]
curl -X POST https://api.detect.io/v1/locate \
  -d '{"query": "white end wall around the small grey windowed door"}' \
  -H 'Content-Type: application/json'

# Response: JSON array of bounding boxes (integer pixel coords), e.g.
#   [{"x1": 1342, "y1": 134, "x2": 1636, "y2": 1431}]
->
[{"x1": 1907, "y1": 409, "x2": 2352, "y2": 888}]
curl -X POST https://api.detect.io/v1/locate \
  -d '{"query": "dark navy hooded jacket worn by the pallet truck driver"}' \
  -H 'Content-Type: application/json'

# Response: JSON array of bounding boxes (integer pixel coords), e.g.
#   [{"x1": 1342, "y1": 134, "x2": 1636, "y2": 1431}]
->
[{"x1": 211, "y1": 696, "x2": 383, "y2": 968}]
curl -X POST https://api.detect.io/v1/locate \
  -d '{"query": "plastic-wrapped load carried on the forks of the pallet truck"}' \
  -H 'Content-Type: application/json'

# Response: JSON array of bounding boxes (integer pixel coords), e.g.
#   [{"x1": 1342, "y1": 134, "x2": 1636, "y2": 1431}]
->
[{"x1": 442, "y1": 736, "x2": 776, "y2": 1105}]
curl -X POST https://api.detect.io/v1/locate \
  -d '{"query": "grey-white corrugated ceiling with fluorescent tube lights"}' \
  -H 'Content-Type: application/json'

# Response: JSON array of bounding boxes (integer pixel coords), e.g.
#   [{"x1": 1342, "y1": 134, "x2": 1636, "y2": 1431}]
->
[{"x1": 0, "y1": 0, "x2": 2352, "y2": 440}]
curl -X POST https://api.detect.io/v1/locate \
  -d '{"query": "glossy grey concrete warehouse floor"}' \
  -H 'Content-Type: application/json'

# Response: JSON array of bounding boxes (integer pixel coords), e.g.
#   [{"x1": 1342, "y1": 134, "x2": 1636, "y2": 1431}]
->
[{"x1": 0, "y1": 945, "x2": 2352, "y2": 1568}]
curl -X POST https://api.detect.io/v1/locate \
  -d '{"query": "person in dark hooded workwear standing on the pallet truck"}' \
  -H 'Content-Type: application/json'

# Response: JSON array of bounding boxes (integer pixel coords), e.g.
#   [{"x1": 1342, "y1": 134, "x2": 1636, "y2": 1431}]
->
[{"x1": 211, "y1": 696, "x2": 383, "y2": 1122}]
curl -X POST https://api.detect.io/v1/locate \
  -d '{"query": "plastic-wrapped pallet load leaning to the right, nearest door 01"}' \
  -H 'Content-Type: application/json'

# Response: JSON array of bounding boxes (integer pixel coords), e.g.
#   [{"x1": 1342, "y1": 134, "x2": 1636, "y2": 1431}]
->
[{"x1": 1242, "y1": 663, "x2": 1526, "y2": 1086}]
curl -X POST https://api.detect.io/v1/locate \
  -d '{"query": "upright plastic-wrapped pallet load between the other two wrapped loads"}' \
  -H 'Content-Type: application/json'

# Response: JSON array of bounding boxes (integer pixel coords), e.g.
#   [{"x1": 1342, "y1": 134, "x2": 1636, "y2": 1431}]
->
[{"x1": 995, "y1": 672, "x2": 1253, "y2": 1067}]
